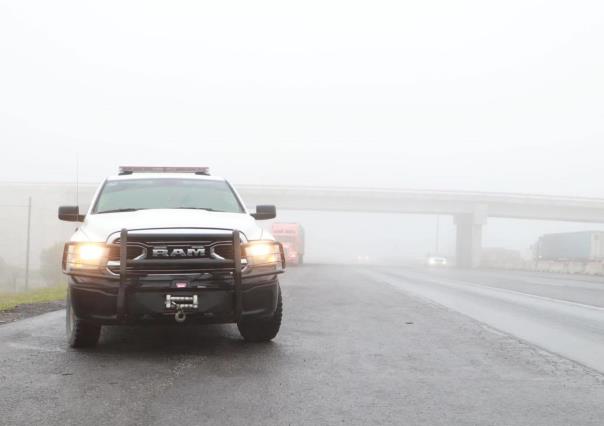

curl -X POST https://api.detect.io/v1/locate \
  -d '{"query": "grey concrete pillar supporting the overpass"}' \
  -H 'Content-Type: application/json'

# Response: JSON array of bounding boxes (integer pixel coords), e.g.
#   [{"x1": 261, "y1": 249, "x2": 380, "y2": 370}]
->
[{"x1": 455, "y1": 206, "x2": 487, "y2": 268}]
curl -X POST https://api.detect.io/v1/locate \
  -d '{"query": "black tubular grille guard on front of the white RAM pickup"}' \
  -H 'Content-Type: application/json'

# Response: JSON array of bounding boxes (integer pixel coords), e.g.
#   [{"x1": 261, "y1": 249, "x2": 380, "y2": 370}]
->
[{"x1": 68, "y1": 228, "x2": 285, "y2": 321}]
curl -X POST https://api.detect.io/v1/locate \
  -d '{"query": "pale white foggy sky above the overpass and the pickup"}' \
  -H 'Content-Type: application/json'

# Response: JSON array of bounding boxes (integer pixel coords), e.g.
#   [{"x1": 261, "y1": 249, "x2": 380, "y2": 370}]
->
[{"x1": 0, "y1": 0, "x2": 604, "y2": 197}]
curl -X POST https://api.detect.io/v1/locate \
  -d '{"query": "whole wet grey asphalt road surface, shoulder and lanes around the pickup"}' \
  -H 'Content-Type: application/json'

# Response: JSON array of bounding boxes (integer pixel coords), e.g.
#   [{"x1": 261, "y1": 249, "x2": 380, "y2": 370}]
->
[{"x1": 0, "y1": 265, "x2": 604, "y2": 425}]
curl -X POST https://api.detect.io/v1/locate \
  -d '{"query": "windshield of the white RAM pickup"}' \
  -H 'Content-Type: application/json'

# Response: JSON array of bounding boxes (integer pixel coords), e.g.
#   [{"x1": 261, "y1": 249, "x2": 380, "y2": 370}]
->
[{"x1": 93, "y1": 178, "x2": 243, "y2": 213}]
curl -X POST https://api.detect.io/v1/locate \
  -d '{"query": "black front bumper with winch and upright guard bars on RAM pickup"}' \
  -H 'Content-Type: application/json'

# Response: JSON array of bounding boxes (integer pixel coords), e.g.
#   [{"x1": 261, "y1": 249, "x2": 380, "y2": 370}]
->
[{"x1": 68, "y1": 229, "x2": 285, "y2": 325}]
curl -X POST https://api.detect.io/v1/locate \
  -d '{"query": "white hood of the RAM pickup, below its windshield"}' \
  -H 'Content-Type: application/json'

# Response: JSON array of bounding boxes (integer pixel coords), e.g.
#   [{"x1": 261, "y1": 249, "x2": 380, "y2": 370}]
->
[{"x1": 72, "y1": 209, "x2": 272, "y2": 242}]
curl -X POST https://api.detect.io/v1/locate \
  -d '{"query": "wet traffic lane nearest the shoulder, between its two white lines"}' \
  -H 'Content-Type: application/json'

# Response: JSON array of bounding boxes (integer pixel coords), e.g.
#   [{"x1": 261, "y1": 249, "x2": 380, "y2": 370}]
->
[{"x1": 362, "y1": 270, "x2": 604, "y2": 372}]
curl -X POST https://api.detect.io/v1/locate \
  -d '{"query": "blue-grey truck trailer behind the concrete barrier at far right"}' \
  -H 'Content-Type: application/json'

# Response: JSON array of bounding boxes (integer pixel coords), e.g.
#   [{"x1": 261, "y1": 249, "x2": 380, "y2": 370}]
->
[{"x1": 535, "y1": 231, "x2": 604, "y2": 261}]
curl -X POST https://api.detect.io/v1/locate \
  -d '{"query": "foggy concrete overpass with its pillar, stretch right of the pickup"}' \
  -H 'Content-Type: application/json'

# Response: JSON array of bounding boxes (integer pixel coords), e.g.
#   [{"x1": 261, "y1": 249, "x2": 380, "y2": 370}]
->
[{"x1": 238, "y1": 185, "x2": 604, "y2": 268}]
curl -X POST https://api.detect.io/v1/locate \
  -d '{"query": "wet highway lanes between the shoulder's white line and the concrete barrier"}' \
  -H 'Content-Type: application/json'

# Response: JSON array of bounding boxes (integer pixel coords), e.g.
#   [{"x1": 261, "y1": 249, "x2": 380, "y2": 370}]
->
[{"x1": 372, "y1": 268, "x2": 604, "y2": 372}]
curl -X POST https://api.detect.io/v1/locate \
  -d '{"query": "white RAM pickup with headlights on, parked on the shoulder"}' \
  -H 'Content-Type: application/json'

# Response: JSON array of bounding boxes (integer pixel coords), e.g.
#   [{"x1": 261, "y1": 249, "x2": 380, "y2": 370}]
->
[{"x1": 59, "y1": 167, "x2": 285, "y2": 347}]
